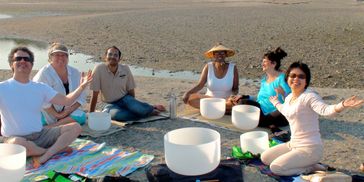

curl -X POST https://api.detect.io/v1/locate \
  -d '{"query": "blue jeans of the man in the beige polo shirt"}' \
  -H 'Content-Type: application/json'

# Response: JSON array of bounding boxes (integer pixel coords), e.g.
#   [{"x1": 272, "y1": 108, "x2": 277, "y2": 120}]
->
[{"x1": 103, "y1": 95, "x2": 153, "y2": 121}]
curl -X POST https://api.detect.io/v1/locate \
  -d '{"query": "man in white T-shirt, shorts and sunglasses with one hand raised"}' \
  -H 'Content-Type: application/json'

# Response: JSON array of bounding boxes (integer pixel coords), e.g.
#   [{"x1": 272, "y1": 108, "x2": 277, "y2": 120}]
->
[{"x1": 0, "y1": 47, "x2": 92, "y2": 167}]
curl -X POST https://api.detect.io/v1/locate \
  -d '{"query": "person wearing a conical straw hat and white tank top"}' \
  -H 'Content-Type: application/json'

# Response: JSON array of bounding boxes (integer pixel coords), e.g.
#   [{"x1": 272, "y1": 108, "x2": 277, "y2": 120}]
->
[{"x1": 183, "y1": 43, "x2": 239, "y2": 111}]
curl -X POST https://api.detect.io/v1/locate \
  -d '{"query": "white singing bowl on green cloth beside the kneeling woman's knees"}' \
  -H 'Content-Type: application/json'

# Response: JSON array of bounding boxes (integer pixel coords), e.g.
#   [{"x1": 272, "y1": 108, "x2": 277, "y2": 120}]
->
[{"x1": 240, "y1": 131, "x2": 269, "y2": 154}]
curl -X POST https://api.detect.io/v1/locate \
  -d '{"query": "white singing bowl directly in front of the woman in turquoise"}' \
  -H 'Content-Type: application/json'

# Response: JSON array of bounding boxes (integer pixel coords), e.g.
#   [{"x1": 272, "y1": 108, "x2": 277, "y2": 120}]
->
[{"x1": 231, "y1": 105, "x2": 260, "y2": 130}]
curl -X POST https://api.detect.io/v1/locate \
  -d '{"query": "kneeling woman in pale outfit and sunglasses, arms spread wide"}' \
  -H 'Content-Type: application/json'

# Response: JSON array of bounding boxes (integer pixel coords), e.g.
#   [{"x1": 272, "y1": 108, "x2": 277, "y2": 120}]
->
[{"x1": 261, "y1": 62, "x2": 364, "y2": 176}]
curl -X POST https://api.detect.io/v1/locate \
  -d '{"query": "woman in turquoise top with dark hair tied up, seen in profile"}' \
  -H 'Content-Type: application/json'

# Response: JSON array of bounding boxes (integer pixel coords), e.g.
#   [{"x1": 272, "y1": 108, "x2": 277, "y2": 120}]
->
[{"x1": 232, "y1": 47, "x2": 291, "y2": 133}]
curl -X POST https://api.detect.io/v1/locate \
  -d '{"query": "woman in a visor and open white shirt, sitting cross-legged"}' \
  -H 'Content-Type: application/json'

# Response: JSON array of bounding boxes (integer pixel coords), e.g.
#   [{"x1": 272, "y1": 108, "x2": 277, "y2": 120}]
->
[{"x1": 33, "y1": 43, "x2": 86, "y2": 127}]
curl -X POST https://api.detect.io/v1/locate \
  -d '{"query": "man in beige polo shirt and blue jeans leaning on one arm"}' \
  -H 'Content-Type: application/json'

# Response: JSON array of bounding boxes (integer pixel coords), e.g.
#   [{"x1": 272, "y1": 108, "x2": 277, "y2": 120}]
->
[{"x1": 90, "y1": 46, "x2": 165, "y2": 121}]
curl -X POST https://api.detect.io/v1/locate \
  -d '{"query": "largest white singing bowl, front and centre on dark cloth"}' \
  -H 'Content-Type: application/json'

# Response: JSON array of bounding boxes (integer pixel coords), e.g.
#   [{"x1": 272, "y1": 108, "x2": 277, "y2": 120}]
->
[{"x1": 164, "y1": 127, "x2": 221, "y2": 176}]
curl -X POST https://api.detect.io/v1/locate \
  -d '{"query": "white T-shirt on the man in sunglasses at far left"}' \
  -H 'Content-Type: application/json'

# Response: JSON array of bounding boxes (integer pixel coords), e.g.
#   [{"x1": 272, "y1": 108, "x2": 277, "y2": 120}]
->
[{"x1": 0, "y1": 78, "x2": 57, "y2": 137}]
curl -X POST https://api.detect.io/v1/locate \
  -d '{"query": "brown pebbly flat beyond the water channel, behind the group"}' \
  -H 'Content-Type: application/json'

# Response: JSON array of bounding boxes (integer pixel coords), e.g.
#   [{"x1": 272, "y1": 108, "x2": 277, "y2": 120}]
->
[{"x1": 0, "y1": 0, "x2": 364, "y2": 89}]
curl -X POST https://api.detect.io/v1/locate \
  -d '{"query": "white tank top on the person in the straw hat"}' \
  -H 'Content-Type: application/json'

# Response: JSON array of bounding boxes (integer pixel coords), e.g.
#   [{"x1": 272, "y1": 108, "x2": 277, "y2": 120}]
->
[{"x1": 206, "y1": 62, "x2": 235, "y2": 99}]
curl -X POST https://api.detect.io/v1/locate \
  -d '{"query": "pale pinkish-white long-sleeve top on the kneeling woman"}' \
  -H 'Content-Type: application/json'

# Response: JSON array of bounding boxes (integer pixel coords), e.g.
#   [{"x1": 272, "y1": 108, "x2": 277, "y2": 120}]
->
[{"x1": 277, "y1": 89, "x2": 336, "y2": 147}]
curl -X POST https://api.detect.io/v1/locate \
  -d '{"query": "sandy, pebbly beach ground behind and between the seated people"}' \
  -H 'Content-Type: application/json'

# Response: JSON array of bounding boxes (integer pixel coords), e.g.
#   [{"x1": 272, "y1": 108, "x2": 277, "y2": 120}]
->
[{"x1": 0, "y1": 0, "x2": 364, "y2": 181}]
